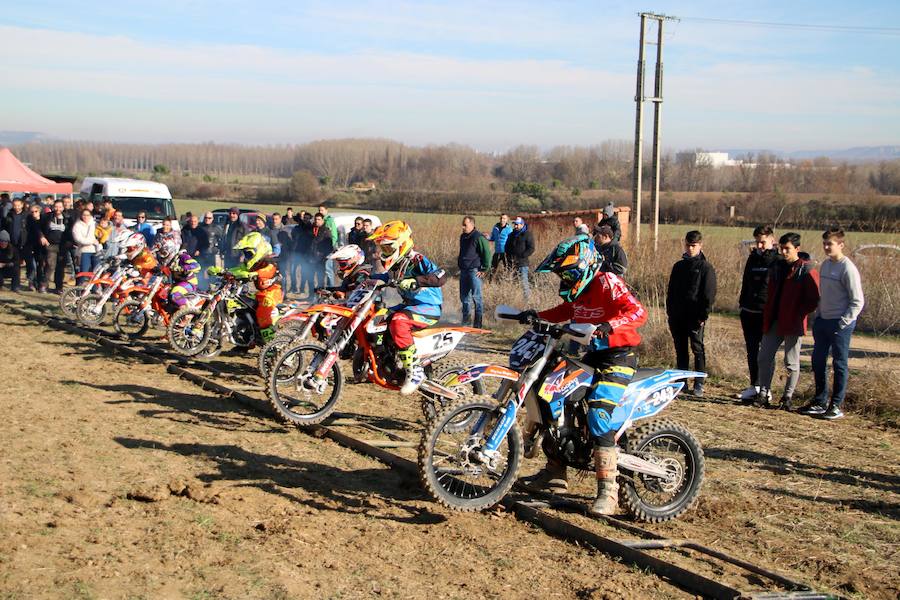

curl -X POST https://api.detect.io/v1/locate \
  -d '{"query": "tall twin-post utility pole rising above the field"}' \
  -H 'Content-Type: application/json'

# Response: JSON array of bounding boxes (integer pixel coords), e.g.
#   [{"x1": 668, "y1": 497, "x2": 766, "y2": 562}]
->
[{"x1": 633, "y1": 13, "x2": 678, "y2": 252}]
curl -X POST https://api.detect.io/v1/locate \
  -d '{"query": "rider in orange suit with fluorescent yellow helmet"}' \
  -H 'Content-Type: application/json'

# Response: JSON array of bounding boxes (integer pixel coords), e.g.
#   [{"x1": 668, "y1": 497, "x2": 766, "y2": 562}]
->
[{"x1": 206, "y1": 231, "x2": 284, "y2": 342}]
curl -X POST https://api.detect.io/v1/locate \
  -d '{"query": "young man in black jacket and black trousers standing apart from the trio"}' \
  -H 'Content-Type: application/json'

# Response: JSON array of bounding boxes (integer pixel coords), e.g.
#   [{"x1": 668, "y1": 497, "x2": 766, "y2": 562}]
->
[{"x1": 666, "y1": 231, "x2": 716, "y2": 397}]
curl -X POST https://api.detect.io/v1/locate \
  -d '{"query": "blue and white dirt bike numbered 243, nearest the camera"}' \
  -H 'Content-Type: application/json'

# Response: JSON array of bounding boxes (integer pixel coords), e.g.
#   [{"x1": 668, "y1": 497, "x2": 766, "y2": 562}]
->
[{"x1": 419, "y1": 306, "x2": 706, "y2": 522}]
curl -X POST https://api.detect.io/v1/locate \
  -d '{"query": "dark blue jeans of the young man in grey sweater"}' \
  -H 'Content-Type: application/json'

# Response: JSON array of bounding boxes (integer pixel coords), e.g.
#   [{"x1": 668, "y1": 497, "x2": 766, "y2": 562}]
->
[{"x1": 812, "y1": 317, "x2": 856, "y2": 408}]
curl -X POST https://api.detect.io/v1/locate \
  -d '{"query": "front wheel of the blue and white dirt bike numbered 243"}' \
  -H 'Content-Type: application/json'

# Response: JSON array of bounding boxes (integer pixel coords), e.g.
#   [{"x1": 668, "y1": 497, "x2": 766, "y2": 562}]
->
[{"x1": 419, "y1": 396, "x2": 522, "y2": 512}]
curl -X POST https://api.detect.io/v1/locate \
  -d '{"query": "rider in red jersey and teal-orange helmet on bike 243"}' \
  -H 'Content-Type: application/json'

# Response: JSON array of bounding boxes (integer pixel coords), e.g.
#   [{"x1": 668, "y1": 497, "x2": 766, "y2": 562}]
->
[{"x1": 519, "y1": 234, "x2": 647, "y2": 515}]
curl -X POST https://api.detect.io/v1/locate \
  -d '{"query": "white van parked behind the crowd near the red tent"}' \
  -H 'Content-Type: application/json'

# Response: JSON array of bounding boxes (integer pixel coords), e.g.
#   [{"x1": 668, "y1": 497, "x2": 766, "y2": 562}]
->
[{"x1": 81, "y1": 177, "x2": 178, "y2": 230}]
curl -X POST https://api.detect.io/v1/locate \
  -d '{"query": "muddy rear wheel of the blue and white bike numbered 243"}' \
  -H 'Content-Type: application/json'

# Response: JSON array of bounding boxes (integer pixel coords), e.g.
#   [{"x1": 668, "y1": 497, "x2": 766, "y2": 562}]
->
[{"x1": 619, "y1": 419, "x2": 704, "y2": 523}]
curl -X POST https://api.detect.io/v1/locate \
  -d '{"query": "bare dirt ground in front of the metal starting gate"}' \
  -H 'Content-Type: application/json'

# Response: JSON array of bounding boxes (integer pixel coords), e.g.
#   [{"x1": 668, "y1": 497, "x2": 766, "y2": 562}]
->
[{"x1": 0, "y1": 311, "x2": 687, "y2": 600}]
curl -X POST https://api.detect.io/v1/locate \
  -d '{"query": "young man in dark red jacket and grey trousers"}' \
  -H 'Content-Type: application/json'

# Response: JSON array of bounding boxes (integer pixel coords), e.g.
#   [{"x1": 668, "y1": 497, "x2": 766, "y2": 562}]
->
[{"x1": 754, "y1": 233, "x2": 819, "y2": 410}]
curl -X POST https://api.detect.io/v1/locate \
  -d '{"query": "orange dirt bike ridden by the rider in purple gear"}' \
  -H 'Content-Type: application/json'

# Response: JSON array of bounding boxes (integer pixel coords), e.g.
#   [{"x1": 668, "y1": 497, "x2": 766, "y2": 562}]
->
[{"x1": 113, "y1": 274, "x2": 204, "y2": 339}]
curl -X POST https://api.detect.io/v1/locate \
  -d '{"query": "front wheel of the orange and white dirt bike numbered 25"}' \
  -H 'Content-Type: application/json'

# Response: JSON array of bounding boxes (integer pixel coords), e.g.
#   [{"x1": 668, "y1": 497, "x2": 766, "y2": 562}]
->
[{"x1": 266, "y1": 344, "x2": 344, "y2": 427}]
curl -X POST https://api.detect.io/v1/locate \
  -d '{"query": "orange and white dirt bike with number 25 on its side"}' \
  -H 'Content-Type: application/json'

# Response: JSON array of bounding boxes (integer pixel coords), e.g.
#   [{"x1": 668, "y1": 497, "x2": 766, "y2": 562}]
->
[{"x1": 266, "y1": 280, "x2": 489, "y2": 426}]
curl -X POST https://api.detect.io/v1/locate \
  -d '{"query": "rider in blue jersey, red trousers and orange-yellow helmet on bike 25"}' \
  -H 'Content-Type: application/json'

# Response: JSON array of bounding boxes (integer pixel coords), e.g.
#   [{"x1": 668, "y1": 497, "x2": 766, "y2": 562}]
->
[{"x1": 369, "y1": 221, "x2": 447, "y2": 394}]
